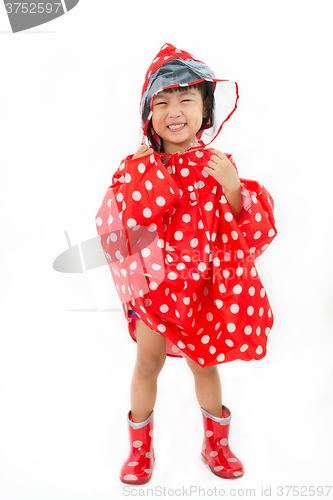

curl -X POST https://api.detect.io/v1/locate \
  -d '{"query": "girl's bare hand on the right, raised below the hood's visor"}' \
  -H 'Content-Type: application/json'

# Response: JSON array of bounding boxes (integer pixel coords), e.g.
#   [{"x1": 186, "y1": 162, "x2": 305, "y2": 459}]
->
[{"x1": 204, "y1": 149, "x2": 240, "y2": 193}]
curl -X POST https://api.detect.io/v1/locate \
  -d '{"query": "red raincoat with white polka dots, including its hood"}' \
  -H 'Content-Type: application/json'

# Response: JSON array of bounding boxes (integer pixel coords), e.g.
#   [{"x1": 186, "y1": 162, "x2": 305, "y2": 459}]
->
[{"x1": 96, "y1": 44, "x2": 276, "y2": 367}]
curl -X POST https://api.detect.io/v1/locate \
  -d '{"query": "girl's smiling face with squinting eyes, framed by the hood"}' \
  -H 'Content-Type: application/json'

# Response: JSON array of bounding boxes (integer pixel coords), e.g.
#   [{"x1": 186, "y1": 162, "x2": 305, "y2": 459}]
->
[{"x1": 152, "y1": 87, "x2": 204, "y2": 154}]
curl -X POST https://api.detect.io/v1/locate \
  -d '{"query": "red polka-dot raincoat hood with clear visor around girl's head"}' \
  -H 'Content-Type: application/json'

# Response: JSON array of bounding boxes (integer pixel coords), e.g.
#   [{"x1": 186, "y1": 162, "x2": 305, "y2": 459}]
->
[{"x1": 140, "y1": 43, "x2": 238, "y2": 146}]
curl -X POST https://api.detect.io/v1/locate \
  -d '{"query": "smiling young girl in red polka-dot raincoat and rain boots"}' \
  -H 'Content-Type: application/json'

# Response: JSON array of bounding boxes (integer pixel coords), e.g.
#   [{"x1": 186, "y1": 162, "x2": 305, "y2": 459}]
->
[{"x1": 96, "y1": 43, "x2": 276, "y2": 484}]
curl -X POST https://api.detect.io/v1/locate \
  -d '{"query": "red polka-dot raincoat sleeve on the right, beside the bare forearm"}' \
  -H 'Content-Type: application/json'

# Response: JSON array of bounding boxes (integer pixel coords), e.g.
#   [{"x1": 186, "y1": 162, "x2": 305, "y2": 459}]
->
[{"x1": 219, "y1": 155, "x2": 277, "y2": 259}]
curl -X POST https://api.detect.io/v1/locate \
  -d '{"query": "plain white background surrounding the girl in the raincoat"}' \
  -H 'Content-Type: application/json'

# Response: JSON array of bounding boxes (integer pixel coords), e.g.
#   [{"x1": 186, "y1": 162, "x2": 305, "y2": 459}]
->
[{"x1": 0, "y1": 0, "x2": 333, "y2": 500}]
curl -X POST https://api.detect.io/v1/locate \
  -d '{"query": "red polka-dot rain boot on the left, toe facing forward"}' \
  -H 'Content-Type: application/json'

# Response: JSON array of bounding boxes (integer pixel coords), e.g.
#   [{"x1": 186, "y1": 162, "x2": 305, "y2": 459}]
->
[{"x1": 120, "y1": 410, "x2": 155, "y2": 484}]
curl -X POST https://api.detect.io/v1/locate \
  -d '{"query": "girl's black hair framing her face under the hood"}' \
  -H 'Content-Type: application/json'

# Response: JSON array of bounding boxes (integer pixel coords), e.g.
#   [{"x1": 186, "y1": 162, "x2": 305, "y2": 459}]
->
[{"x1": 142, "y1": 80, "x2": 215, "y2": 153}]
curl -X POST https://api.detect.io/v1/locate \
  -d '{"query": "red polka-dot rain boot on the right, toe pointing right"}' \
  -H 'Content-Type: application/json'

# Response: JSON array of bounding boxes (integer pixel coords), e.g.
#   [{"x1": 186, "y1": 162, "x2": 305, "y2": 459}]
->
[{"x1": 201, "y1": 405, "x2": 244, "y2": 479}]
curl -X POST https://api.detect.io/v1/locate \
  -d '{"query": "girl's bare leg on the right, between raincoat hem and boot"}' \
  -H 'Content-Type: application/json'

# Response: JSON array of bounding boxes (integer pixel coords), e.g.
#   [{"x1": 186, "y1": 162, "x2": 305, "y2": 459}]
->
[{"x1": 186, "y1": 356, "x2": 222, "y2": 418}]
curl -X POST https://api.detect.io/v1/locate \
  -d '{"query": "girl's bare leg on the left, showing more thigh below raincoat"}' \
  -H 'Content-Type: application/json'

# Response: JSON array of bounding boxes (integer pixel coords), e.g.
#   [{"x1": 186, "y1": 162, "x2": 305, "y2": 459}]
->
[{"x1": 131, "y1": 319, "x2": 166, "y2": 422}]
